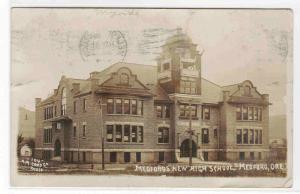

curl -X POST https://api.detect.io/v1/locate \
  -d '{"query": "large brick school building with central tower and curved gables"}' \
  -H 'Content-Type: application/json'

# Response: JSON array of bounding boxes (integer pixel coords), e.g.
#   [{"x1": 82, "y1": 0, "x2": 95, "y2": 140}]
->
[{"x1": 36, "y1": 31, "x2": 270, "y2": 163}]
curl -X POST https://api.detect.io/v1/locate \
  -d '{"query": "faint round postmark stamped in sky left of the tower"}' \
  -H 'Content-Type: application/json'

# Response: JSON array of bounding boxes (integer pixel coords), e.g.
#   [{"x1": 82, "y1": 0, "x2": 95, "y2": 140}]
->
[{"x1": 79, "y1": 30, "x2": 128, "y2": 63}]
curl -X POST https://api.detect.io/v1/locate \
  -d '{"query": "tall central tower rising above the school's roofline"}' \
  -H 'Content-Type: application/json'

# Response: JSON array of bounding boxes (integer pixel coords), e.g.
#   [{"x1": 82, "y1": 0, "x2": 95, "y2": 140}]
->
[{"x1": 157, "y1": 28, "x2": 202, "y2": 95}]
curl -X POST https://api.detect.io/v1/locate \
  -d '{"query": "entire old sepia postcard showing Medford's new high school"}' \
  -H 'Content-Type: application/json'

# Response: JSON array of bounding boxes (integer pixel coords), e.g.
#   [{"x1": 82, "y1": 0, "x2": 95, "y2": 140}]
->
[{"x1": 10, "y1": 7, "x2": 293, "y2": 187}]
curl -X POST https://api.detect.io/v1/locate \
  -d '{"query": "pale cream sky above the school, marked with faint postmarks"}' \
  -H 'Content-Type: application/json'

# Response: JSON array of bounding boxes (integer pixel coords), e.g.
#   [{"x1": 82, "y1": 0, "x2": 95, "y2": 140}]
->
[{"x1": 11, "y1": 8, "x2": 293, "y2": 115}]
